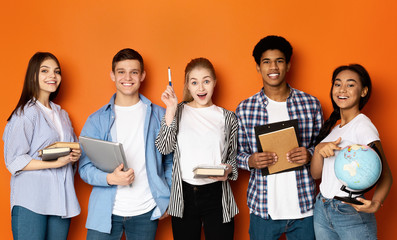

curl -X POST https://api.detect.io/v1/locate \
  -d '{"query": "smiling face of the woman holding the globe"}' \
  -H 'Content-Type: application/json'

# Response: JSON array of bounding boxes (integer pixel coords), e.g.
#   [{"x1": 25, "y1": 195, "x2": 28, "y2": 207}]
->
[{"x1": 332, "y1": 70, "x2": 368, "y2": 111}]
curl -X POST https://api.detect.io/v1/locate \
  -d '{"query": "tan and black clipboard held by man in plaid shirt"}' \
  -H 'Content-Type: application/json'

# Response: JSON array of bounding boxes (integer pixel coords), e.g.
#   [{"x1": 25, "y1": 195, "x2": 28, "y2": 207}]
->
[{"x1": 255, "y1": 119, "x2": 303, "y2": 175}]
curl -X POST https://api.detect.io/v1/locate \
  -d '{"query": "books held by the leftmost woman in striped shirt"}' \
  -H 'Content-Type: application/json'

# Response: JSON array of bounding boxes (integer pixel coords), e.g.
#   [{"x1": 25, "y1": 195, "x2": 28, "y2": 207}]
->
[{"x1": 39, "y1": 142, "x2": 80, "y2": 161}]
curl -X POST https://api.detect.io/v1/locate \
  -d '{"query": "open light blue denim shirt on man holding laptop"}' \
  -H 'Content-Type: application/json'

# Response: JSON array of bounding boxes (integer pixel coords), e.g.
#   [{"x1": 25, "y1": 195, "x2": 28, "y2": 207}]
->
[{"x1": 79, "y1": 94, "x2": 172, "y2": 233}]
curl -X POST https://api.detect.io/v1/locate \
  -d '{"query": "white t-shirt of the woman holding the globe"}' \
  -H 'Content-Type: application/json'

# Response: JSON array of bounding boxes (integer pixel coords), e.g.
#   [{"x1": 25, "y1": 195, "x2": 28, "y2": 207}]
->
[{"x1": 320, "y1": 113, "x2": 379, "y2": 198}]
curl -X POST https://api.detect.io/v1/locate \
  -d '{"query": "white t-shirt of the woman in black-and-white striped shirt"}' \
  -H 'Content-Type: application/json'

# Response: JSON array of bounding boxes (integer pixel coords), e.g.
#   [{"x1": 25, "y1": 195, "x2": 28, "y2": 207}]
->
[{"x1": 178, "y1": 105, "x2": 225, "y2": 185}]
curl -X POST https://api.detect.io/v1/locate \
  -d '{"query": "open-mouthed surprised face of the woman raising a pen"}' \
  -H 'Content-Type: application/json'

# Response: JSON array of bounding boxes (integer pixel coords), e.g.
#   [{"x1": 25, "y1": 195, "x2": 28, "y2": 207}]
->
[{"x1": 187, "y1": 68, "x2": 216, "y2": 108}]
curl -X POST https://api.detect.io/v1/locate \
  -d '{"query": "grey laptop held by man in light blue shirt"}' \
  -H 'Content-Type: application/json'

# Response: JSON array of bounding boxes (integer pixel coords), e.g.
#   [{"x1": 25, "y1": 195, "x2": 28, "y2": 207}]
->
[{"x1": 79, "y1": 136, "x2": 128, "y2": 173}]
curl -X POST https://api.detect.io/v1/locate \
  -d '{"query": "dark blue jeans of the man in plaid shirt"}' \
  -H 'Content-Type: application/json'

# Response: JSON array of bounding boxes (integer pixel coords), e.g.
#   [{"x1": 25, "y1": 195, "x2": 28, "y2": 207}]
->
[{"x1": 249, "y1": 213, "x2": 314, "y2": 240}]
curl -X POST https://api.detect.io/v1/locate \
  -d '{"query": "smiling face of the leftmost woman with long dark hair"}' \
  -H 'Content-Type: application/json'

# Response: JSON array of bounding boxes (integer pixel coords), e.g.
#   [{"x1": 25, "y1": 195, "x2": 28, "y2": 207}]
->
[{"x1": 38, "y1": 58, "x2": 61, "y2": 102}]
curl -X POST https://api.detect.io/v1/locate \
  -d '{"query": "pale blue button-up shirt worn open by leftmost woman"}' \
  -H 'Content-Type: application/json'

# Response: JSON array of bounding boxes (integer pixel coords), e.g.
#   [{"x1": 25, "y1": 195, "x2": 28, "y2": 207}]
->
[{"x1": 3, "y1": 102, "x2": 80, "y2": 218}]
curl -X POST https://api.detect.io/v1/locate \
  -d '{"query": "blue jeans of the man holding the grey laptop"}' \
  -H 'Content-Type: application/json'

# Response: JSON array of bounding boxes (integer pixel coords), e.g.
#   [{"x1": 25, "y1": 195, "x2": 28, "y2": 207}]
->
[{"x1": 87, "y1": 209, "x2": 158, "y2": 240}]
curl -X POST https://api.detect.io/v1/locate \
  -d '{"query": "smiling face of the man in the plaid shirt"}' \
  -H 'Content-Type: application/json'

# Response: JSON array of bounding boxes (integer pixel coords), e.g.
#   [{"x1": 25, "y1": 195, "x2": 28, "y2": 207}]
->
[{"x1": 256, "y1": 49, "x2": 290, "y2": 88}]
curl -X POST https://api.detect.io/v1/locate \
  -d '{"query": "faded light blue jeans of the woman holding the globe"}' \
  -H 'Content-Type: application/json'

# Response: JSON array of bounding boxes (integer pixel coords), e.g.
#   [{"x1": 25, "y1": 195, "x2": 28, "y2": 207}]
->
[{"x1": 314, "y1": 193, "x2": 377, "y2": 240}]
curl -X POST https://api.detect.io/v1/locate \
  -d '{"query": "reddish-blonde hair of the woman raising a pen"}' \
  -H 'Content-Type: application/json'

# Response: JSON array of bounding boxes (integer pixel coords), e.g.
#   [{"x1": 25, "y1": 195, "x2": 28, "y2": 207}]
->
[{"x1": 183, "y1": 58, "x2": 216, "y2": 102}]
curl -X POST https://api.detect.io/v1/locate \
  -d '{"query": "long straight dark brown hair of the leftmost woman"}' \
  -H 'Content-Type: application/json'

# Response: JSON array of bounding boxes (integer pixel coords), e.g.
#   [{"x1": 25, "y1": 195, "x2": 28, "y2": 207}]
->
[{"x1": 7, "y1": 52, "x2": 61, "y2": 121}]
